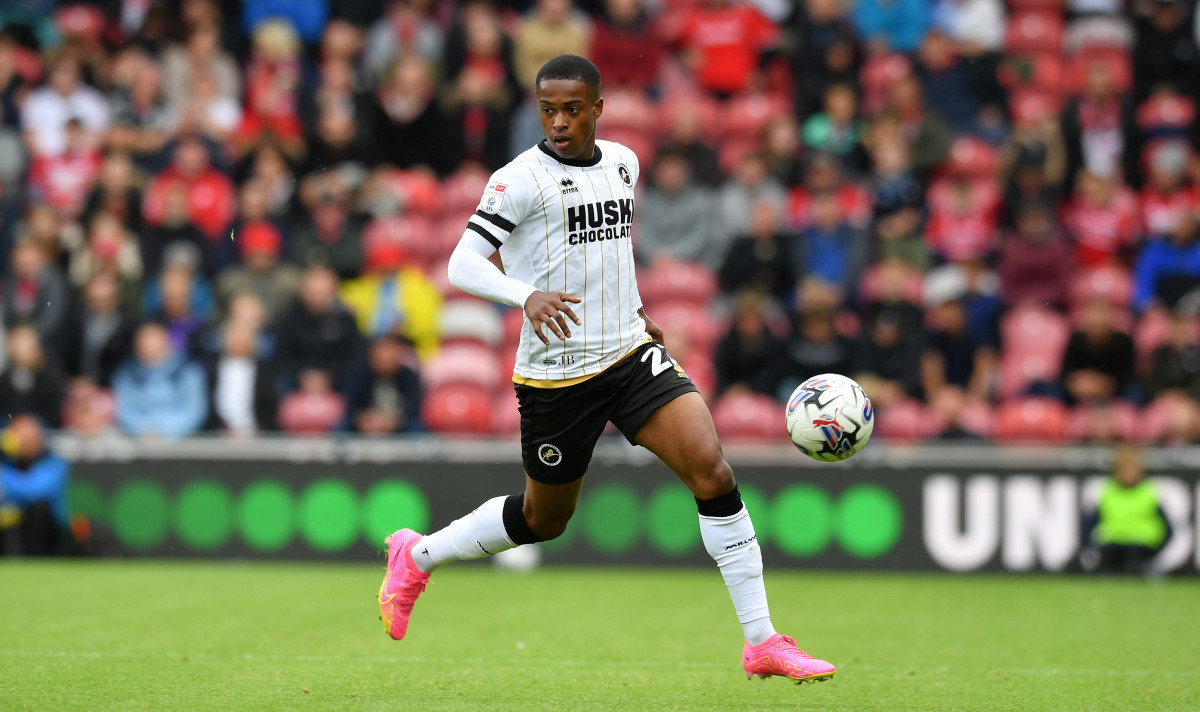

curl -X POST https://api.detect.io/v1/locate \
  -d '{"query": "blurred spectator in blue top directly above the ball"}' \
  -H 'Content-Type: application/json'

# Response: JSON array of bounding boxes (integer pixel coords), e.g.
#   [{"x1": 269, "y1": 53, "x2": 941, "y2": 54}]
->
[{"x1": 792, "y1": 191, "x2": 866, "y2": 299}]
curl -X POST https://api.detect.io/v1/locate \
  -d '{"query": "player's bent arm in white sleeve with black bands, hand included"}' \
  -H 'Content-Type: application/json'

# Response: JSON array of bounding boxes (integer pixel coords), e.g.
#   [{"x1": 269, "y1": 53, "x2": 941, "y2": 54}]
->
[{"x1": 448, "y1": 170, "x2": 582, "y2": 343}]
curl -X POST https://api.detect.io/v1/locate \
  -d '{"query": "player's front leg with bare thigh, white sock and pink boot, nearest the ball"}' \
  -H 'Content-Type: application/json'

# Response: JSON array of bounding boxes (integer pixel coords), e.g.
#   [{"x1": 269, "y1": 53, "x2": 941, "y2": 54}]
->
[{"x1": 634, "y1": 384, "x2": 836, "y2": 683}]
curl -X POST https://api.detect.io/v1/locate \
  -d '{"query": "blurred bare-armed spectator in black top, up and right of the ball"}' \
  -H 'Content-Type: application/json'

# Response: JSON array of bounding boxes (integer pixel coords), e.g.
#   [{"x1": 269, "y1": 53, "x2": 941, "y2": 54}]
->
[{"x1": 920, "y1": 300, "x2": 996, "y2": 401}]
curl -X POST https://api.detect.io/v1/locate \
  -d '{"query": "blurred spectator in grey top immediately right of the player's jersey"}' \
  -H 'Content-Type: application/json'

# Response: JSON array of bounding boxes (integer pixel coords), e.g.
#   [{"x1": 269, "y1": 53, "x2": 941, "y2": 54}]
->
[{"x1": 634, "y1": 150, "x2": 722, "y2": 269}]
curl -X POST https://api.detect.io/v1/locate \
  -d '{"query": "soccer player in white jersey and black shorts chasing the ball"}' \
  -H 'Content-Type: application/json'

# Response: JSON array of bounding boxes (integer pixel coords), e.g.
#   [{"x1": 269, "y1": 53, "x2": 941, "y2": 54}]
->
[{"x1": 379, "y1": 55, "x2": 836, "y2": 683}]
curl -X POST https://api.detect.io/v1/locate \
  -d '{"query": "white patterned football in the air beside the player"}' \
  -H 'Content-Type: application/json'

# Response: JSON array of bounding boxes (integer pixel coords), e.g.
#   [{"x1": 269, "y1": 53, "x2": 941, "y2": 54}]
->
[{"x1": 785, "y1": 373, "x2": 875, "y2": 462}]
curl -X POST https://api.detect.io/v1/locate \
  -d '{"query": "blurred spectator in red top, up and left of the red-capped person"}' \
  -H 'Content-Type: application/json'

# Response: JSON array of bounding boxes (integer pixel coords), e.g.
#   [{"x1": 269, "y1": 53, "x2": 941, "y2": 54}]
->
[{"x1": 143, "y1": 137, "x2": 236, "y2": 240}]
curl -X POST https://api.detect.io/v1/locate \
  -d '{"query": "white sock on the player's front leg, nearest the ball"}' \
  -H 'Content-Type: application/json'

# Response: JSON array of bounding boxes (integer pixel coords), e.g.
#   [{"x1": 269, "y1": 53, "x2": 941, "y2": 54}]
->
[{"x1": 700, "y1": 505, "x2": 775, "y2": 645}]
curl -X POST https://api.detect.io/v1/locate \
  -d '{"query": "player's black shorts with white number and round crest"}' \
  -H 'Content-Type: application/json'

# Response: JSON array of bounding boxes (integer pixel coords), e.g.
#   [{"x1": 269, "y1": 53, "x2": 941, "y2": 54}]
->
[{"x1": 516, "y1": 342, "x2": 696, "y2": 485}]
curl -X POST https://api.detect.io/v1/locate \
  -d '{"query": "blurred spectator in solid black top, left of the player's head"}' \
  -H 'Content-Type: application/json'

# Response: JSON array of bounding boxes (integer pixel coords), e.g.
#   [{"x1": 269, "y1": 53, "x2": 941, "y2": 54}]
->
[{"x1": 376, "y1": 56, "x2": 451, "y2": 175}]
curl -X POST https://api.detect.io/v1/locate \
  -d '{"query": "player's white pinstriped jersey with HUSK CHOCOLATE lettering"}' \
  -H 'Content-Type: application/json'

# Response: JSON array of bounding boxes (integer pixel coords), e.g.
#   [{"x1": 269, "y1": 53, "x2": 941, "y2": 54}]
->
[{"x1": 467, "y1": 140, "x2": 649, "y2": 388}]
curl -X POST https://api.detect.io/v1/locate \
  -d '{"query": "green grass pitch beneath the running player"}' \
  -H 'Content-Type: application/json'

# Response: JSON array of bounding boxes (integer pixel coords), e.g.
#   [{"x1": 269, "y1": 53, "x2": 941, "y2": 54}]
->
[{"x1": 0, "y1": 562, "x2": 1200, "y2": 712}]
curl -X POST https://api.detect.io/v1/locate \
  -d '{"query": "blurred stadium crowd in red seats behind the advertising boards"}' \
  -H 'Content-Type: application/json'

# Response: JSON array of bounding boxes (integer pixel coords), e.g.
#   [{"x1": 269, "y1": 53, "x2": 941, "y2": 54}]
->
[{"x1": 0, "y1": 0, "x2": 1200, "y2": 443}]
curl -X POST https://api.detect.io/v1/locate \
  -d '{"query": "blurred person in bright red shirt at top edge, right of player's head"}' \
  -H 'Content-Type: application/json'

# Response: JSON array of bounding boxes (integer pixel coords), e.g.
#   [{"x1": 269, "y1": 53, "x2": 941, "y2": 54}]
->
[{"x1": 678, "y1": 0, "x2": 776, "y2": 97}]
